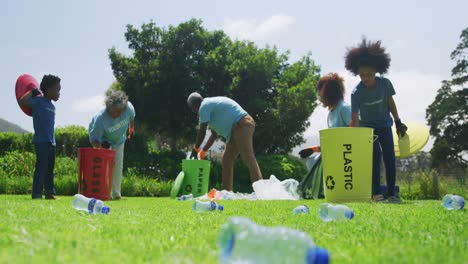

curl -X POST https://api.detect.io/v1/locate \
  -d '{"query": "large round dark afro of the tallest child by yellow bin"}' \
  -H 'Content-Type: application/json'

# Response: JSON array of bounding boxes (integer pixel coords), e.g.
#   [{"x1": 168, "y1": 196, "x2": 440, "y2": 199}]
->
[{"x1": 345, "y1": 38, "x2": 390, "y2": 75}]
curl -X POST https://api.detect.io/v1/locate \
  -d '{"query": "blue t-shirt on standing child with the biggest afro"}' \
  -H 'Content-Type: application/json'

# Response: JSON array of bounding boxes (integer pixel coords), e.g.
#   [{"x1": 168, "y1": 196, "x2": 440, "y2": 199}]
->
[{"x1": 351, "y1": 77, "x2": 395, "y2": 128}]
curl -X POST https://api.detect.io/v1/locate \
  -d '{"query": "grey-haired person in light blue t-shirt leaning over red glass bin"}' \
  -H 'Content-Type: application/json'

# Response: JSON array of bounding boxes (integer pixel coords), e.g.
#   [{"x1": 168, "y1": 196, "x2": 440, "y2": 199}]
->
[{"x1": 88, "y1": 91, "x2": 135, "y2": 200}]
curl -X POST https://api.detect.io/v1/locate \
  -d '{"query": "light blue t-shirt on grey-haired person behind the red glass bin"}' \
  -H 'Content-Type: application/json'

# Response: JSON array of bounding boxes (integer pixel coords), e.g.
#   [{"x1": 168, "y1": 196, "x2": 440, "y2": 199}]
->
[{"x1": 88, "y1": 102, "x2": 135, "y2": 148}]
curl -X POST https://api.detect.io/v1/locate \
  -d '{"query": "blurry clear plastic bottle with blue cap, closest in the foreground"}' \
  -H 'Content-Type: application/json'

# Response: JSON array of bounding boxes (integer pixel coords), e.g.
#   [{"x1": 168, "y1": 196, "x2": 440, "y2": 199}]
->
[{"x1": 217, "y1": 217, "x2": 330, "y2": 264}]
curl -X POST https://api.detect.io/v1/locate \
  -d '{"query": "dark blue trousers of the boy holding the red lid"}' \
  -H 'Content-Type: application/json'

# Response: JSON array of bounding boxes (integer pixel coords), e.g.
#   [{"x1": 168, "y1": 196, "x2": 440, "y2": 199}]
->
[{"x1": 32, "y1": 142, "x2": 55, "y2": 198}]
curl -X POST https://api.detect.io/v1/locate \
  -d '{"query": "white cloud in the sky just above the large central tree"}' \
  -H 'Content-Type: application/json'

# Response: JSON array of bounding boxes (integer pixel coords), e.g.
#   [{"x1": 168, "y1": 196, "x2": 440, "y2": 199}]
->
[{"x1": 223, "y1": 15, "x2": 294, "y2": 40}]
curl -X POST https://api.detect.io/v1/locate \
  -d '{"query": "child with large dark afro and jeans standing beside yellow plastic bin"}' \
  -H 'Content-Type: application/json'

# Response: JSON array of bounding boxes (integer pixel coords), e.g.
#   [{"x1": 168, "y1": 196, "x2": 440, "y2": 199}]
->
[{"x1": 345, "y1": 38, "x2": 407, "y2": 203}]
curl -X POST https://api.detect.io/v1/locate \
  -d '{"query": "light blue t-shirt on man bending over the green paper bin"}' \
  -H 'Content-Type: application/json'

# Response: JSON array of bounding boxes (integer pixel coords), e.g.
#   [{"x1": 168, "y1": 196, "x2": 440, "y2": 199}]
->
[{"x1": 198, "y1": 96, "x2": 247, "y2": 142}]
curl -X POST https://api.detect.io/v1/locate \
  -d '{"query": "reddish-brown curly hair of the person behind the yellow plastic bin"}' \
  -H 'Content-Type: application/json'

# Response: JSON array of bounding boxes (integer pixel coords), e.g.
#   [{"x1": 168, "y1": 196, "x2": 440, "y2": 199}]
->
[{"x1": 317, "y1": 72, "x2": 345, "y2": 107}]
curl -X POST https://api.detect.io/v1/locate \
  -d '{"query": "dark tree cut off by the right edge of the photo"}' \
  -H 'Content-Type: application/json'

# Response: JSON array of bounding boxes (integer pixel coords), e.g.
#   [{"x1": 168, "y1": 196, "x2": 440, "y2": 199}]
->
[{"x1": 426, "y1": 28, "x2": 468, "y2": 167}]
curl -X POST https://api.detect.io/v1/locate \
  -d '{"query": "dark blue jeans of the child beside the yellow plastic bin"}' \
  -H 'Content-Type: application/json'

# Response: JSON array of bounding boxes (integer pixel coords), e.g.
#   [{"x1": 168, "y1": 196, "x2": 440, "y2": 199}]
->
[{"x1": 372, "y1": 127, "x2": 396, "y2": 196}]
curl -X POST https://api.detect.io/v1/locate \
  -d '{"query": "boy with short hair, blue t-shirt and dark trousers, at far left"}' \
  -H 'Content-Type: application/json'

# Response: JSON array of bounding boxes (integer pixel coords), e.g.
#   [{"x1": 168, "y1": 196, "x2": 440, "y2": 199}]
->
[{"x1": 19, "y1": 75, "x2": 61, "y2": 200}]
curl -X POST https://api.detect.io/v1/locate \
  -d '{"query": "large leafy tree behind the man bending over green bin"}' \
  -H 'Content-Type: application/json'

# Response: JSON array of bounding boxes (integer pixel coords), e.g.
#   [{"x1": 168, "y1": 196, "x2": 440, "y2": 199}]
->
[{"x1": 109, "y1": 19, "x2": 319, "y2": 153}]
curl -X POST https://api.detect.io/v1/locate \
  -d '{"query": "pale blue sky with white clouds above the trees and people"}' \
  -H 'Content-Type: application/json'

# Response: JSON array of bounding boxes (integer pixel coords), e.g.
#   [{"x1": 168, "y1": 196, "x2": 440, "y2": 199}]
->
[{"x1": 0, "y1": 0, "x2": 468, "y2": 150}]
